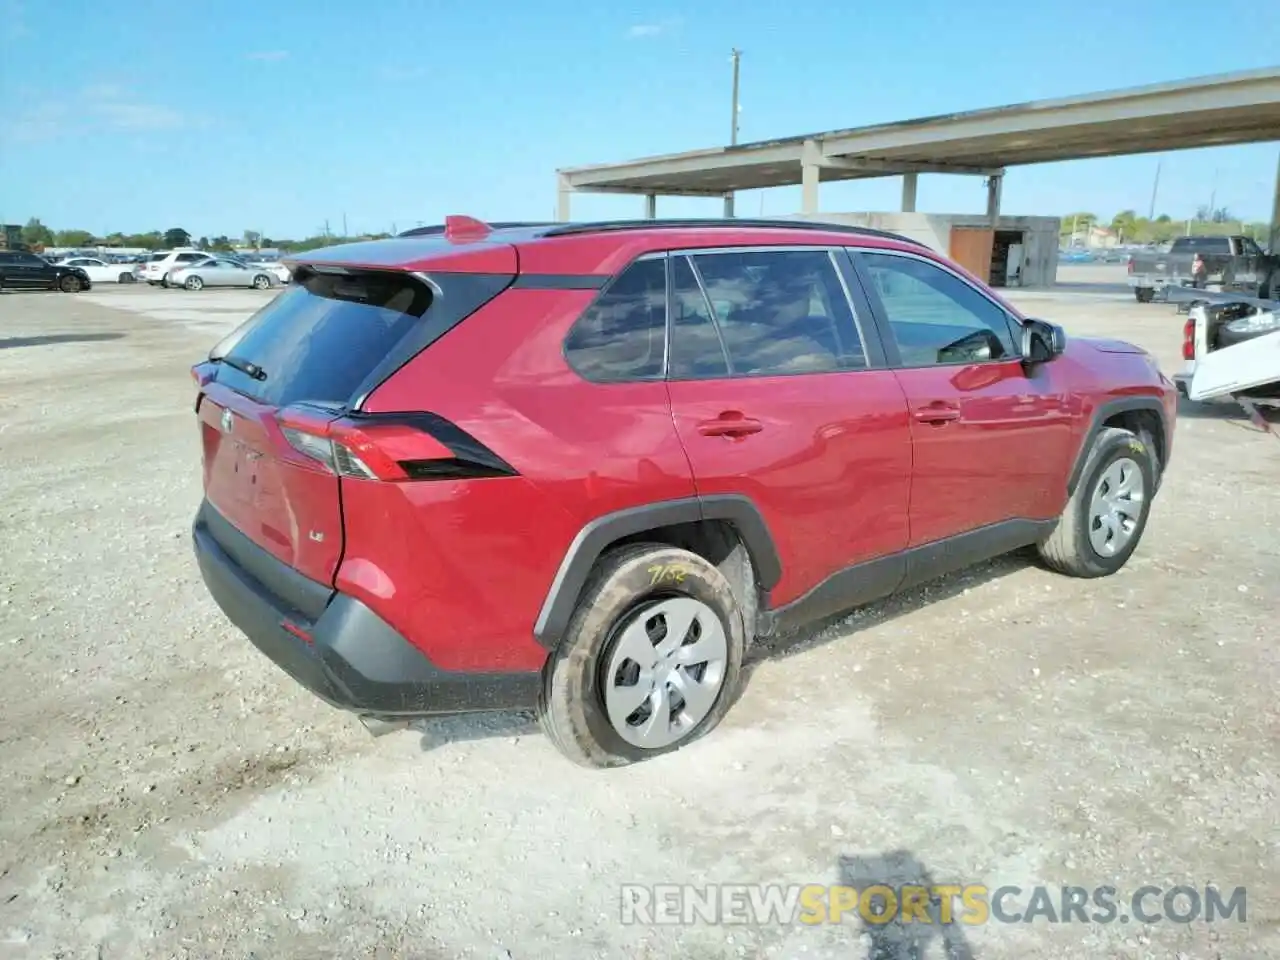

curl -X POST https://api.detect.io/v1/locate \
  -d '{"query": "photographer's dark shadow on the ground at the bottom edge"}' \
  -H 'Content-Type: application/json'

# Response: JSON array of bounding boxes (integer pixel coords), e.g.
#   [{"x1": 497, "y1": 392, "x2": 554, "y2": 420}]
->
[{"x1": 837, "y1": 850, "x2": 974, "y2": 960}]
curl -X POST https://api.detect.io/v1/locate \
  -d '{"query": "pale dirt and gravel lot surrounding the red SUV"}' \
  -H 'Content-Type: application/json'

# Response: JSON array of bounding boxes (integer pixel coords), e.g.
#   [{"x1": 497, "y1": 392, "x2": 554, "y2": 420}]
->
[{"x1": 0, "y1": 268, "x2": 1280, "y2": 960}]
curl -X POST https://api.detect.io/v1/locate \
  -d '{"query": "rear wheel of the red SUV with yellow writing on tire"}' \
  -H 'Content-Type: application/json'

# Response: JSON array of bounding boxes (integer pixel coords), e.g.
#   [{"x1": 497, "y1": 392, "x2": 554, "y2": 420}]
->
[{"x1": 538, "y1": 543, "x2": 746, "y2": 768}]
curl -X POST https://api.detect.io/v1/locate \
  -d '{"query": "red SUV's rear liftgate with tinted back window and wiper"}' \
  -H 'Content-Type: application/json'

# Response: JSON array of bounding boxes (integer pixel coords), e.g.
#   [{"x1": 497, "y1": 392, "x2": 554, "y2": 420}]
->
[{"x1": 189, "y1": 274, "x2": 450, "y2": 582}]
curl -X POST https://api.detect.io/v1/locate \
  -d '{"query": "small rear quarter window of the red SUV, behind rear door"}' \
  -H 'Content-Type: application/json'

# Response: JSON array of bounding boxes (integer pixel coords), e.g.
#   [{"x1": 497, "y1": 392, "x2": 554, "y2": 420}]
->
[{"x1": 564, "y1": 257, "x2": 667, "y2": 383}]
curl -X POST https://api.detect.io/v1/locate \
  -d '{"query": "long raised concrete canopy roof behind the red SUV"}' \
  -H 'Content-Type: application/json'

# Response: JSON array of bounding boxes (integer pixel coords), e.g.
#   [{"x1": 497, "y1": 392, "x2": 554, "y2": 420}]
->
[{"x1": 558, "y1": 68, "x2": 1280, "y2": 200}]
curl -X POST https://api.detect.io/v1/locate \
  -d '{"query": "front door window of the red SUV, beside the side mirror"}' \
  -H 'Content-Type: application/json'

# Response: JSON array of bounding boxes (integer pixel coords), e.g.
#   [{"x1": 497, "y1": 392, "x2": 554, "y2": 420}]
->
[{"x1": 861, "y1": 251, "x2": 1018, "y2": 366}]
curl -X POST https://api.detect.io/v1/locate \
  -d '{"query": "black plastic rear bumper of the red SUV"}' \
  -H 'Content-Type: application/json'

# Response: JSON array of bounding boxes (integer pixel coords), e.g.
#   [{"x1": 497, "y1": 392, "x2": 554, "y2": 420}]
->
[{"x1": 192, "y1": 503, "x2": 541, "y2": 719}]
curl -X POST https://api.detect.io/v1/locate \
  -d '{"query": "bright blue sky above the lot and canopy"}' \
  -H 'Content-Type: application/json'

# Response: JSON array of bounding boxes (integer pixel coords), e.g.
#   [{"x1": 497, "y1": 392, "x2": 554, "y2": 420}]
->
[{"x1": 0, "y1": 0, "x2": 1280, "y2": 237}]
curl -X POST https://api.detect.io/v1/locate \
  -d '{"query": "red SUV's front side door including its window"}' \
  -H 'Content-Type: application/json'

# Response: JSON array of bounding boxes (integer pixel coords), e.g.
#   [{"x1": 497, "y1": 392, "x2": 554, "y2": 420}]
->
[{"x1": 854, "y1": 251, "x2": 1079, "y2": 547}]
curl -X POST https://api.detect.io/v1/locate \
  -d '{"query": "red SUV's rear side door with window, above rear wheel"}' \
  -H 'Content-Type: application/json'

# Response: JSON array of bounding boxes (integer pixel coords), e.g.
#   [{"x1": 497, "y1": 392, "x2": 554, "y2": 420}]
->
[{"x1": 668, "y1": 248, "x2": 911, "y2": 607}]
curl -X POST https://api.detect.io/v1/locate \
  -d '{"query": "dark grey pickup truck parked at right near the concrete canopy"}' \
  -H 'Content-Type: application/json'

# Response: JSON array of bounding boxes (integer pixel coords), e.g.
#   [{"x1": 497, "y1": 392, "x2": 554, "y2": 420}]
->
[{"x1": 1129, "y1": 236, "x2": 1280, "y2": 303}]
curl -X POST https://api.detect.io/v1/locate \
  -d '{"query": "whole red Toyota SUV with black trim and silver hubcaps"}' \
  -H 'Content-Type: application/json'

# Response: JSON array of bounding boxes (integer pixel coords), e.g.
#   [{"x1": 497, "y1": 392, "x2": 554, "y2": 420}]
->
[{"x1": 193, "y1": 218, "x2": 1176, "y2": 767}]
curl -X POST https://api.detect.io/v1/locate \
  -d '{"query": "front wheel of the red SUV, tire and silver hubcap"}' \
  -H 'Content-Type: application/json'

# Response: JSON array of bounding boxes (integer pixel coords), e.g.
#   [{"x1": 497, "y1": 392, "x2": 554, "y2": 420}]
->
[{"x1": 1038, "y1": 426, "x2": 1160, "y2": 577}]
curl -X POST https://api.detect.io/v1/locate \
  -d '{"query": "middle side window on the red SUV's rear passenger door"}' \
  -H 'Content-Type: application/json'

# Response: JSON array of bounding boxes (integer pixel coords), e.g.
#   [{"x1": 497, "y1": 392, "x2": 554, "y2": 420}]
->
[{"x1": 692, "y1": 250, "x2": 867, "y2": 376}]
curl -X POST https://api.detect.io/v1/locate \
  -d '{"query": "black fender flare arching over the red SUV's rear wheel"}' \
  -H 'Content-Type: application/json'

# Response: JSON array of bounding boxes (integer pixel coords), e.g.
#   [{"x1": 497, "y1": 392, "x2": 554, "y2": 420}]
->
[{"x1": 534, "y1": 494, "x2": 782, "y2": 649}]
